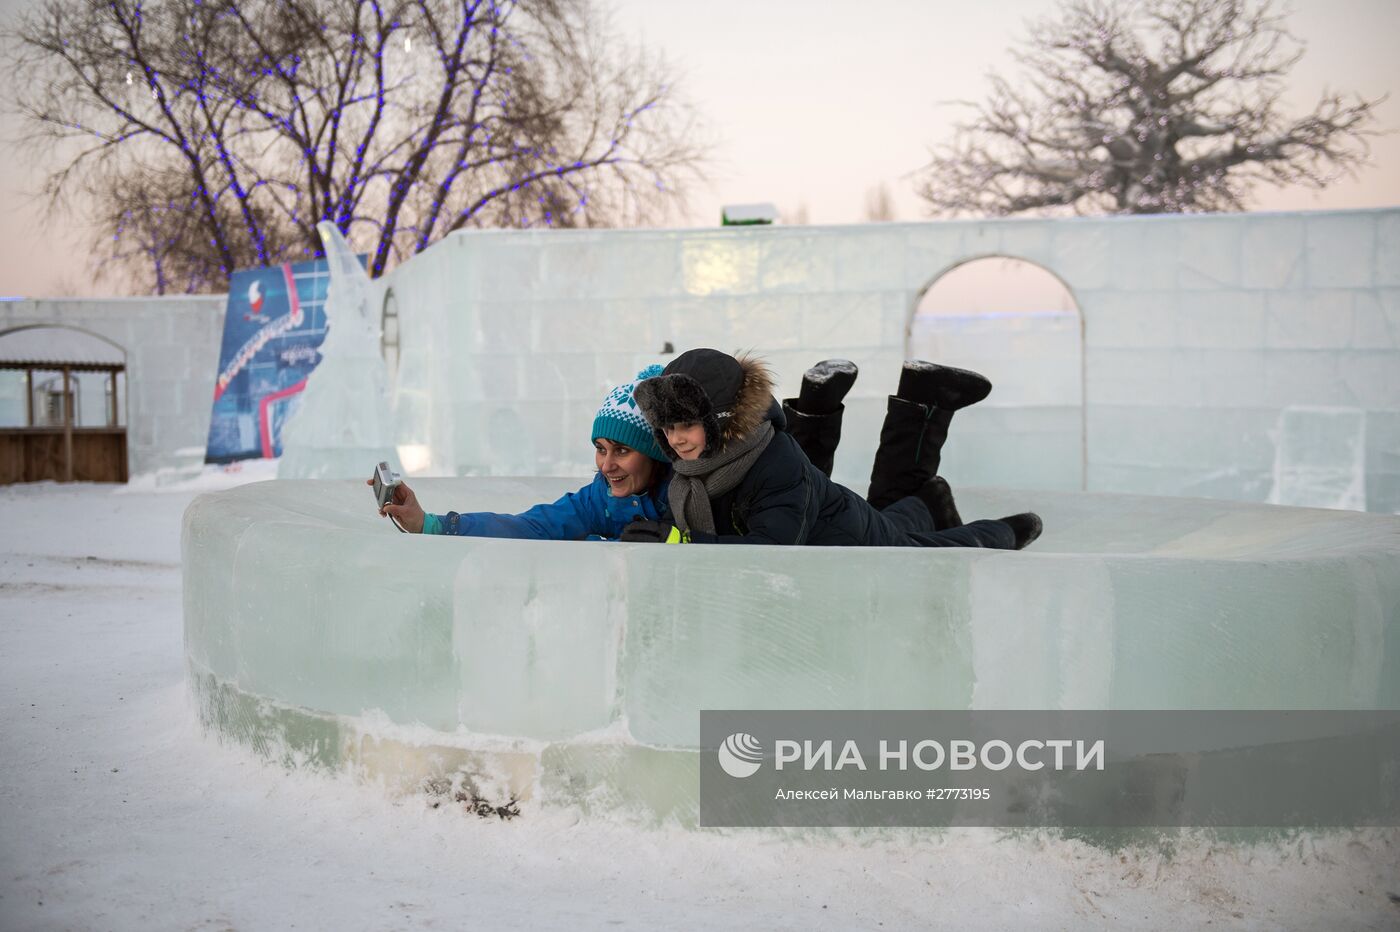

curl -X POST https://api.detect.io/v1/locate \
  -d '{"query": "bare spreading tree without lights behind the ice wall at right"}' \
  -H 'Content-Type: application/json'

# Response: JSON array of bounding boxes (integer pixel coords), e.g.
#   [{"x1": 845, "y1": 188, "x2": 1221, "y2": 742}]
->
[{"x1": 918, "y1": 0, "x2": 1385, "y2": 214}]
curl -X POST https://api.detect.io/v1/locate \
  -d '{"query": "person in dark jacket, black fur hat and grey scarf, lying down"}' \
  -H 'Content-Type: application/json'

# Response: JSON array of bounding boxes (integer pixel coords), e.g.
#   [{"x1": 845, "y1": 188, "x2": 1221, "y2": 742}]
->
[{"x1": 623, "y1": 350, "x2": 1040, "y2": 550}]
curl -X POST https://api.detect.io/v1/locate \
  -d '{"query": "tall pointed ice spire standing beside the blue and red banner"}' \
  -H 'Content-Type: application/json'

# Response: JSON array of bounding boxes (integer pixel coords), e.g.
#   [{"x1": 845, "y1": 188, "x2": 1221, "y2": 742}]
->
[{"x1": 277, "y1": 221, "x2": 402, "y2": 479}]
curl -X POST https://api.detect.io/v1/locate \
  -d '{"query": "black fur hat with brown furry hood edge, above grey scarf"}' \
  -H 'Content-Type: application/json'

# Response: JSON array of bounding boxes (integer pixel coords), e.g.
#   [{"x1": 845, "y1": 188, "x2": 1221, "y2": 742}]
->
[{"x1": 636, "y1": 348, "x2": 773, "y2": 459}]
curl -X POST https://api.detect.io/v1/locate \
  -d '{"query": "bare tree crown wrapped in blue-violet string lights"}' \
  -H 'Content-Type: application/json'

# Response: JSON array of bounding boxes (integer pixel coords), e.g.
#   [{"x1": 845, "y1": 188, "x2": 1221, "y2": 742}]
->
[{"x1": 11, "y1": 0, "x2": 704, "y2": 291}]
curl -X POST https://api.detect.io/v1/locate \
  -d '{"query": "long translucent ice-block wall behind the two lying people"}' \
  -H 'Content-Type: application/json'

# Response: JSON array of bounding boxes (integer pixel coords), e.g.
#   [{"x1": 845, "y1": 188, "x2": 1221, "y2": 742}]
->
[{"x1": 375, "y1": 209, "x2": 1400, "y2": 512}]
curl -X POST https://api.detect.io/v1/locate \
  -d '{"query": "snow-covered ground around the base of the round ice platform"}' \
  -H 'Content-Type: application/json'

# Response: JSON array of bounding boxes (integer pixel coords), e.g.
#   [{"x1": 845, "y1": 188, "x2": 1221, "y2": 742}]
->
[{"x1": 0, "y1": 481, "x2": 1400, "y2": 929}]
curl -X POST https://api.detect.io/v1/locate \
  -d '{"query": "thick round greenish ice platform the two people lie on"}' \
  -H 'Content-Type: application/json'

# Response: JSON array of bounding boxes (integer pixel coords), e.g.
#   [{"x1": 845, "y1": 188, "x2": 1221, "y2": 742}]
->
[{"x1": 182, "y1": 479, "x2": 1400, "y2": 809}]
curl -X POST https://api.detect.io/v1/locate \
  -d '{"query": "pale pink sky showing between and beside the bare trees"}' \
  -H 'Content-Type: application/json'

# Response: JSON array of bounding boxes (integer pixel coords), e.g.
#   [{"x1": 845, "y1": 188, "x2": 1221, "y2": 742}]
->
[{"x1": 0, "y1": 0, "x2": 1400, "y2": 297}]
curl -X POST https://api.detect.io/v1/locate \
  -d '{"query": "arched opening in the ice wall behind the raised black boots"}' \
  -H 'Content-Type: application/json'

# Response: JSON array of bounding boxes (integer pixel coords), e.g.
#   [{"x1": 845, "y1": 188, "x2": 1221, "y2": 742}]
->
[{"x1": 904, "y1": 250, "x2": 1085, "y2": 490}]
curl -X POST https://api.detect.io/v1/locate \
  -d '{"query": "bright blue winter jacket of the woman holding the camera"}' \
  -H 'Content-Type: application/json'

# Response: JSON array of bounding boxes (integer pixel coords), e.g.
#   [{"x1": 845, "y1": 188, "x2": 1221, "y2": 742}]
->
[{"x1": 423, "y1": 470, "x2": 671, "y2": 540}]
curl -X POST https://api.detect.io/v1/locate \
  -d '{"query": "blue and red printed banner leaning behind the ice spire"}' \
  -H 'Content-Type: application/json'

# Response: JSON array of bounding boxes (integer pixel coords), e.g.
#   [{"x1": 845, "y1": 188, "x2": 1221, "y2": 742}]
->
[{"x1": 204, "y1": 259, "x2": 350, "y2": 463}]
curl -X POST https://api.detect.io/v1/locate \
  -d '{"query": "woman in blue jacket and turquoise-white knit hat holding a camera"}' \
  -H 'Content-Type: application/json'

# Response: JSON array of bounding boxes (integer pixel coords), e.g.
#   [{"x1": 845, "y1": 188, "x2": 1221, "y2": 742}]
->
[{"x1": 379, "y1": 365, "x2": 671, "y2": 540}]
